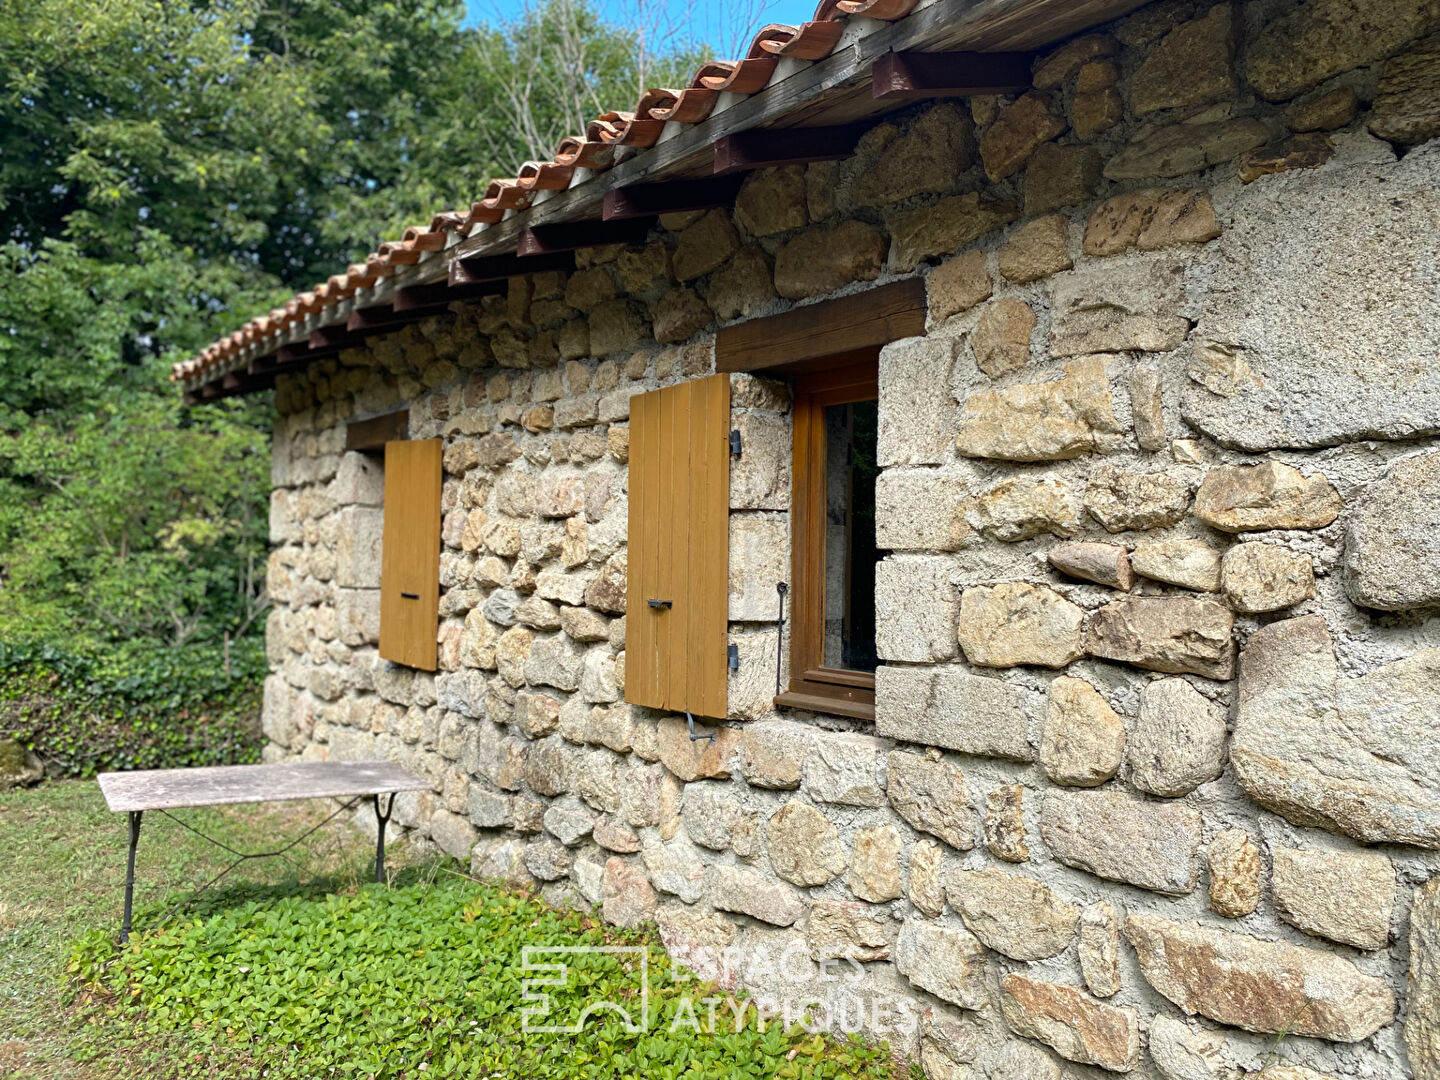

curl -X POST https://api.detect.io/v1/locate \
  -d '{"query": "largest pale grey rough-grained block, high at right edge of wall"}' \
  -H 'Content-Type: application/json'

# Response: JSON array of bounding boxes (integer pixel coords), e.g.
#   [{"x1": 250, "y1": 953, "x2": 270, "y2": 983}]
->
[{"x1": 1182, "y1": 144, "x2": 1440, "y2": 452}]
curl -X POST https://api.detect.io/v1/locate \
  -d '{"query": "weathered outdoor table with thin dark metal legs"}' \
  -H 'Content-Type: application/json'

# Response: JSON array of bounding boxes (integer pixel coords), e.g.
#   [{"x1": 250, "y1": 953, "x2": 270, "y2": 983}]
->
[{"x1": 96, "y1": 762, "x2": 431, "y2": 942}]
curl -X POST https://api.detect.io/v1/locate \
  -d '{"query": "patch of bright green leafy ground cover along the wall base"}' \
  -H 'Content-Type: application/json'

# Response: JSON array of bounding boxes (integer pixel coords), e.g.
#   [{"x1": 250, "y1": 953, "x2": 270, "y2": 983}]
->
[{"x1": 71, "y1": 876, "x2": 891, "y2": 1080}]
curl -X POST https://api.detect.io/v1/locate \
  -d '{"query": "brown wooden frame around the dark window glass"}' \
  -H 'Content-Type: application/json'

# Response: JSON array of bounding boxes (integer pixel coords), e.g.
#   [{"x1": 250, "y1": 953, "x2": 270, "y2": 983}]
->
[{"x1": 775, "y1": 360, "x2": 880, "y2": 720}]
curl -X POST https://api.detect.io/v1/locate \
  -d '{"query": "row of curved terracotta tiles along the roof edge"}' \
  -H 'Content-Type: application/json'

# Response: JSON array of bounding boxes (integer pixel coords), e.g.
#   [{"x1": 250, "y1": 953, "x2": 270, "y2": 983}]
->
[{"x1": 170, "y1": 0, "x2": 917, "y2": 382}]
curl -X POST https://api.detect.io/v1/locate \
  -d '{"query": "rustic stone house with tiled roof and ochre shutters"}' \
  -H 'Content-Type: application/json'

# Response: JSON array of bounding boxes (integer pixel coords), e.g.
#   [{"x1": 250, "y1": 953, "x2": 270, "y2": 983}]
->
[{"x1": 176, "y1": 0, "x2": 1440, "y2": 1080}]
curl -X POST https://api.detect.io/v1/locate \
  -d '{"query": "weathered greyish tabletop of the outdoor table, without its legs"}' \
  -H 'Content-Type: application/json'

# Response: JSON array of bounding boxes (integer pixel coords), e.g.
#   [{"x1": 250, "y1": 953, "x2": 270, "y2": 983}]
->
[{"x1": 96, "y1": 762, "x2": 431, "y2": 812}]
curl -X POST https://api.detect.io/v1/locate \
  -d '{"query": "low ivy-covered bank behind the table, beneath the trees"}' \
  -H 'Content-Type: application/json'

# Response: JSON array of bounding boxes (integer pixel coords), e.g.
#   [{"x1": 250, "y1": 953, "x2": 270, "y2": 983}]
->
[{"x1": 0, "y1": 639, "x2": 265, "y2": 776}]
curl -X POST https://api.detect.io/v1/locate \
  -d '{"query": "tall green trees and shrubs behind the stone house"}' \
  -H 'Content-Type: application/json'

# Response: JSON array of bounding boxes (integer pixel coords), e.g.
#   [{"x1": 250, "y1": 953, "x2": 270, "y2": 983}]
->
[{"x1": 0, "y1": 0, "x2": 691, "y2": 731}]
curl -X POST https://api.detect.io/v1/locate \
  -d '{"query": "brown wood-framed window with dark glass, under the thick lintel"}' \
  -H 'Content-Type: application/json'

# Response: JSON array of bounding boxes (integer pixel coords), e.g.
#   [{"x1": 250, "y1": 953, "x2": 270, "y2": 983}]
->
[{"x1": 775, "y1": 360, "x2": 880, "y2": 720}]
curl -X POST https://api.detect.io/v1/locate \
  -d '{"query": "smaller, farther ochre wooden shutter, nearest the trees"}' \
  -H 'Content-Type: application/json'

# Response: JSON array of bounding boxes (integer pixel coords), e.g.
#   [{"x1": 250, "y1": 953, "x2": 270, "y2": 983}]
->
[{"x1": 380, "y1": 439, "x2": 441, "y2": 671}]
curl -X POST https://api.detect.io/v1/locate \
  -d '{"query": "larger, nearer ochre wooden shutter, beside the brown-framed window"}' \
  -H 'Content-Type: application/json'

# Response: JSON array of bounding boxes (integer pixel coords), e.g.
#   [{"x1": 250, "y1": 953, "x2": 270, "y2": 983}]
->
[{"x1": 625, "y1": 374, "x2": 730, "y2": 717}]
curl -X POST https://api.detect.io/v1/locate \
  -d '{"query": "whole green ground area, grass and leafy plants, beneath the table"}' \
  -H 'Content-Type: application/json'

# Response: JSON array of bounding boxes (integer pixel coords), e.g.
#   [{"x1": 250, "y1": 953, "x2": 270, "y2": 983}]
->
[{"x1": 0, "y1": 782, "x2": 904, "y2": 1080}]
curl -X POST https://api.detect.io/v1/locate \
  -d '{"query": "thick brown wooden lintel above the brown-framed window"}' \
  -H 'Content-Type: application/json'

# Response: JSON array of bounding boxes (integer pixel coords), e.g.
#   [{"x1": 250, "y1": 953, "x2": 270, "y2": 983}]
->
[{"x1": 716, "y1": 278, "x2": 926, "y2": 372}]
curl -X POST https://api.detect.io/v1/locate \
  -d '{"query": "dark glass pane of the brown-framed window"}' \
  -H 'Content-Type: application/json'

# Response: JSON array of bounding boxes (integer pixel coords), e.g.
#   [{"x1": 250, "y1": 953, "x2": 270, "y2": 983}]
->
[{"x1": 825, "y1": 402, "x2": 880, "y2": 671}]
